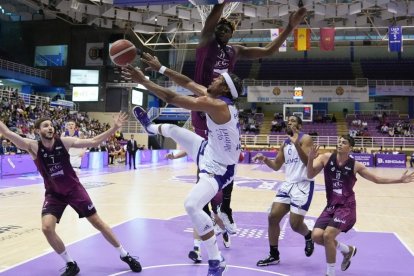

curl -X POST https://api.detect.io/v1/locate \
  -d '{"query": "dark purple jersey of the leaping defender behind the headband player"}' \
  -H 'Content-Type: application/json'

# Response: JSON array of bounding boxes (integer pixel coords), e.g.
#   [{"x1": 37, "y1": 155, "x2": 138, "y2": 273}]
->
[{"x1": 191, "y1": 39, "x2": 236, "y2": 139}]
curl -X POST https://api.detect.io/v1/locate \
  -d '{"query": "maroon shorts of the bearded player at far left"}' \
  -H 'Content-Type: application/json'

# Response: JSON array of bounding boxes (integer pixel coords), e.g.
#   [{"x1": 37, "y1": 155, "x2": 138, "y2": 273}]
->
[{"x1": 42, "y1": 187, "x2": 96, "y2": 222}]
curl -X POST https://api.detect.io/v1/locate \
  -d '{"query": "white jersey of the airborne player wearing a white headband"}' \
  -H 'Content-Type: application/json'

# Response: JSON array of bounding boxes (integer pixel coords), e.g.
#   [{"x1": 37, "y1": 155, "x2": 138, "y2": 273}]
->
[{"x1": 200, "y1": 100, "x2": 241, "y2": 175}]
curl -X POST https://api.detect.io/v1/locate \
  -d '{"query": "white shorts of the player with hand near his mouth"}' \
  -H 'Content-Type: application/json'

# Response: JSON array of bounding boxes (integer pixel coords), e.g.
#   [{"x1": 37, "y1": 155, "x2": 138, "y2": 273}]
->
[{"x1": 273, "y1": 180, "x2": 315, "y2": 216}]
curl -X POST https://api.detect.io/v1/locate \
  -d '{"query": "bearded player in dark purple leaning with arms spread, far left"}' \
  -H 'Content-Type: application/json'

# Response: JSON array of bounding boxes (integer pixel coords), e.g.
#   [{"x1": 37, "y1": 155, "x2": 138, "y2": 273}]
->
[{"x1": 0, "y1": 113, "x2": 142, "y2": 276}]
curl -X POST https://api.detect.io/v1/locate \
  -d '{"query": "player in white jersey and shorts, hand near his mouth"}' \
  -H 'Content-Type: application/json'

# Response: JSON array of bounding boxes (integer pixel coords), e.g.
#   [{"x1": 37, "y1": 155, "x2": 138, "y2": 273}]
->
[{"x1": 253, "y1": 116, "x2": 314, "y2": 266}]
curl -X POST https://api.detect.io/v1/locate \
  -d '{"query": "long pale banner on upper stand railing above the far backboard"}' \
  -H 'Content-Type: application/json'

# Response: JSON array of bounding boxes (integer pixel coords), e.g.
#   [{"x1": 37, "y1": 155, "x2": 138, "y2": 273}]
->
[{"x1": 247, "y1": 85, "x2": 369, "y2": 103}]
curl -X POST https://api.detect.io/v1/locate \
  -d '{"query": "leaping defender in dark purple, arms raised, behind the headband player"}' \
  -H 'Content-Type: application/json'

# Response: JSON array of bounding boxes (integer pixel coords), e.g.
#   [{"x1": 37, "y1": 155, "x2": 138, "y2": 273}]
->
[{"x1": 191, "y1": 3, "x2": 306, "y2": 237}]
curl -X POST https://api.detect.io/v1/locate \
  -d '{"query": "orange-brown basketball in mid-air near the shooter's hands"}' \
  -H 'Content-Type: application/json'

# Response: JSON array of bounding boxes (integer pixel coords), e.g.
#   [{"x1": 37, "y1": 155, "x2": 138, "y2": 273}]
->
[{"x1": 109, "y1": 39, "x2": 137, "y2": 66}]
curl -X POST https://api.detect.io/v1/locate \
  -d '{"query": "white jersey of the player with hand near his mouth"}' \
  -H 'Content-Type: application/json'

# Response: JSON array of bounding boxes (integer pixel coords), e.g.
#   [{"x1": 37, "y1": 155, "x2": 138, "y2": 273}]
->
[{"x1": 283, "y1": 134, "x2": 310, "y2": 183}]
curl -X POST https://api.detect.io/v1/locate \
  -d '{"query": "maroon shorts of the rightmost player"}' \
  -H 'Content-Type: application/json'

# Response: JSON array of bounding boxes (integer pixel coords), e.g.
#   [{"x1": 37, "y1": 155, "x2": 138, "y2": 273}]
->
[{"x1": 314, "y1": 202, "x2": 356, "y2": 232}]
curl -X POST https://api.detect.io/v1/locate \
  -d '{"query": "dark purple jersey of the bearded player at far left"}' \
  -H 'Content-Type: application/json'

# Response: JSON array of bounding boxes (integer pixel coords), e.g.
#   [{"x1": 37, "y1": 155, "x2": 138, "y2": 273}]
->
[{"x1": 34, "y1": 137, "x2": 83, "y2": 195}]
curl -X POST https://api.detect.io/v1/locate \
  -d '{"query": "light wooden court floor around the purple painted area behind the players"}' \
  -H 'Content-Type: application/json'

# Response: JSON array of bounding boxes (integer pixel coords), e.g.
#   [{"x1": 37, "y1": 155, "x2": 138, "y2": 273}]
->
[{"x1": 0, "y1": 161, "x2": 414, "y2": 271}]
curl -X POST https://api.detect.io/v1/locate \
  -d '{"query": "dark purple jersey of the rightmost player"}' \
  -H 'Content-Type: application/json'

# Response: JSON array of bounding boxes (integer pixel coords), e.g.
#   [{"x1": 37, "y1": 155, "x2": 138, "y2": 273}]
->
[{"x1": 324, "y1": 152, "x2": 357, "y2": 206}]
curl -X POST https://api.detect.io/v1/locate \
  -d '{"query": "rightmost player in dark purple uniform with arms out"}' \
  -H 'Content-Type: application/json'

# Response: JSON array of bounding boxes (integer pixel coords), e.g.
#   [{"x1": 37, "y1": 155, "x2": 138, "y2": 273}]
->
[{"x1": 307, "y1": 135, "x2": 414, "y2": 276}]
